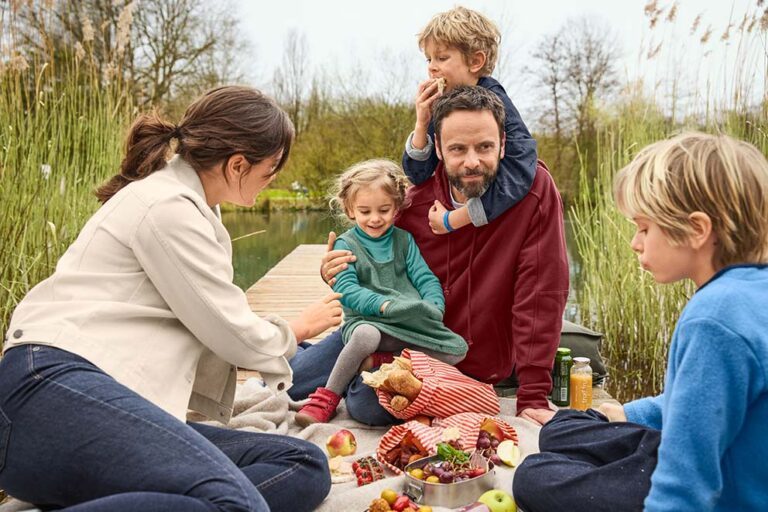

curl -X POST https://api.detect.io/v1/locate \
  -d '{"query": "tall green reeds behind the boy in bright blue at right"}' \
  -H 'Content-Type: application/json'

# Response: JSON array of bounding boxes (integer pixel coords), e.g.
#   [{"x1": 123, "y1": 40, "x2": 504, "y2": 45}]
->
[{"x1": 571, "y1": 111, "x2": 768, "y2": 402}]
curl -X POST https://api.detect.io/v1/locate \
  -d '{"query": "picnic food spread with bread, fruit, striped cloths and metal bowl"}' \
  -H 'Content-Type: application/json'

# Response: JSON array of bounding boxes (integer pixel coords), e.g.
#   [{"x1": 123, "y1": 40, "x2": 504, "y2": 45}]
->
[{"x1": 327, "y1": 349, "x2": 520, "y2": 512}]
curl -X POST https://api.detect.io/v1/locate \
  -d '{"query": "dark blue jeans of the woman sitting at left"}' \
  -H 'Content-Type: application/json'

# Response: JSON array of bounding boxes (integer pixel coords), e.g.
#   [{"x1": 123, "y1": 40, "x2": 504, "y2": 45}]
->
[{"x1": 0, "y1": 345, "x2": 331, "y2": 512}]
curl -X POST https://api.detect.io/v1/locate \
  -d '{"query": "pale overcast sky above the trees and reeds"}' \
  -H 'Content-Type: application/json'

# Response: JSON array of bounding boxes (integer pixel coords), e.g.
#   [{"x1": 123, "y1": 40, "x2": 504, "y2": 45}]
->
[{"x1": 236, "y1": 0, "x2": 765, "y2": 124}]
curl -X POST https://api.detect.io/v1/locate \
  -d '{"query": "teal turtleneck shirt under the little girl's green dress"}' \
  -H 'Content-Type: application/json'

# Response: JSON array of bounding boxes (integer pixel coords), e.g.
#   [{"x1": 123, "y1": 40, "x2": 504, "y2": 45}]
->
[{"x1": 333, "y1": 226, "x2": 445, "y2": 316}]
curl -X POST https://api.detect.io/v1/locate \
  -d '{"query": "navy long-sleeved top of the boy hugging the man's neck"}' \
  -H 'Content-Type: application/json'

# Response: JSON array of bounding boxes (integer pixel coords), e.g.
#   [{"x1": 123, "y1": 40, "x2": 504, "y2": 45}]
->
[{"x1": 403, "y1": 76, "x2": 538, "y2": 226}]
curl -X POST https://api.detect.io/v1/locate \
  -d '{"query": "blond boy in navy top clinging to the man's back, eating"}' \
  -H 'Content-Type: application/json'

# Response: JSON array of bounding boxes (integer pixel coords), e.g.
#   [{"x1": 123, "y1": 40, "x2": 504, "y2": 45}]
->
[{"x1": 403, "y1": 7, "x2": 537, "y2": 234}]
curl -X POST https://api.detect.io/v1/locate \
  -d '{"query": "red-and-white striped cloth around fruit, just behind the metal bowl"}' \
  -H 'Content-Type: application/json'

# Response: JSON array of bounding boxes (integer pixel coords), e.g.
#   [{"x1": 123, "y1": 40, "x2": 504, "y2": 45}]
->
[{"x1": 376, "y1": 412, "x2": 518, "y2": 474}]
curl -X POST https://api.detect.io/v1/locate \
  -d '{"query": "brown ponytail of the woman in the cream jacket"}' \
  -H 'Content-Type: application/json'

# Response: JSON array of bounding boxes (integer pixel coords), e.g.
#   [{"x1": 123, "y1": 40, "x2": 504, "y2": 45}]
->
[{"x1": 96, "y1": 112, "x2": 181, "y2": 204}]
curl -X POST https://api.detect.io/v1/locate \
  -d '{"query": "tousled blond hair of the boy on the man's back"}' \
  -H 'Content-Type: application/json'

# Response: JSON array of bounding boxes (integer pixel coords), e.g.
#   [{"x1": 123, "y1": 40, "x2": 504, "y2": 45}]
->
[{"x1": 419, "y1": 6, "x2": 501, "y2": 76}]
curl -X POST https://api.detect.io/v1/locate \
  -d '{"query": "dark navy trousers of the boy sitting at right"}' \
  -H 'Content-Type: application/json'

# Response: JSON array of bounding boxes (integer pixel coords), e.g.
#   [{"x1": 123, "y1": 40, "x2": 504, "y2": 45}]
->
[{"x1": 512, "y1": 409, "x2": 661, "y2": 512}]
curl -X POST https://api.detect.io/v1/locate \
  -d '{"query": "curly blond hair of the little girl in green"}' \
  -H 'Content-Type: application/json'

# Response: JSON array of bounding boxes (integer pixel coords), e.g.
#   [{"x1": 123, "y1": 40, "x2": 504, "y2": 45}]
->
[{"x1": 329, "y1": 158, "x2": 410, "y2": 224}]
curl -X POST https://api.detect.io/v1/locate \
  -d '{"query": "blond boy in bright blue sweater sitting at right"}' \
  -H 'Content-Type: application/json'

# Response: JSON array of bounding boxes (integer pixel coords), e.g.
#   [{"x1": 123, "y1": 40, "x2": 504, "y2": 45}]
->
[{"x1": 513, "y1": 133, "x2": 768, "y2": 512}]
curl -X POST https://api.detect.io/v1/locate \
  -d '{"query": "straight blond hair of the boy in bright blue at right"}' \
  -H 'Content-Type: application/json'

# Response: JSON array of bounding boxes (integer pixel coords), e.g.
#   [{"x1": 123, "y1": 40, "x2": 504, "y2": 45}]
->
[{"x1": 613, "y1": 132, "x2": 768, "y2": 269}]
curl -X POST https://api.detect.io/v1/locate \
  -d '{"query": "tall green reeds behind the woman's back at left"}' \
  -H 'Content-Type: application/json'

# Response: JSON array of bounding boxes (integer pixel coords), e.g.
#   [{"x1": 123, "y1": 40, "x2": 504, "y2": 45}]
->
[{"x1": 0, "y1": 47, "x2": 131, "y2": 344}]
